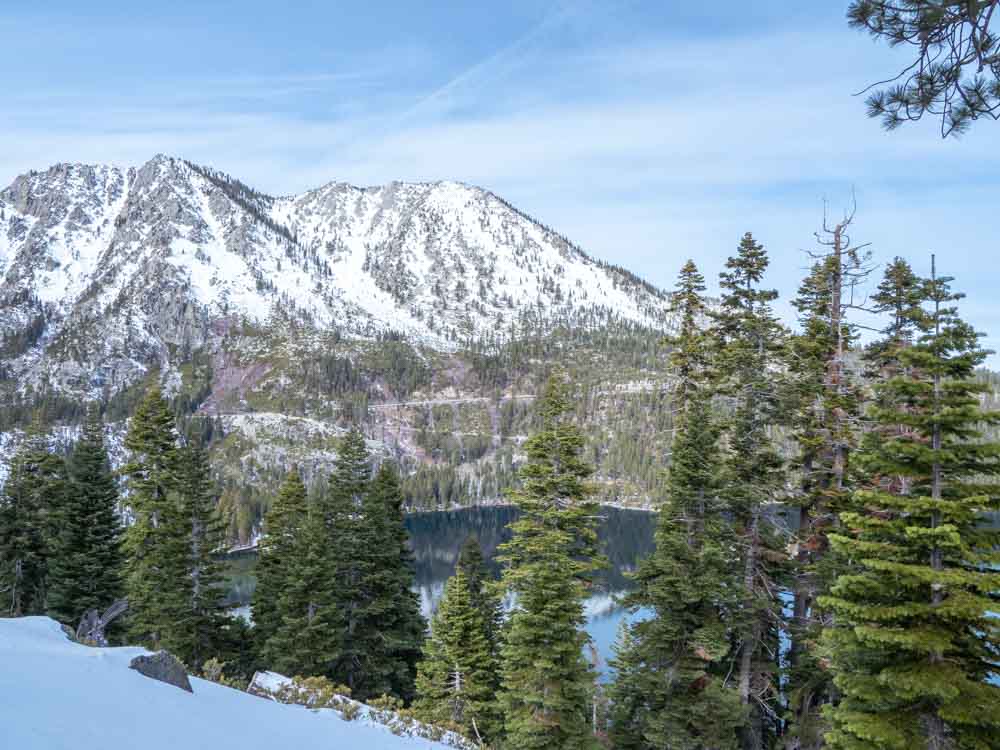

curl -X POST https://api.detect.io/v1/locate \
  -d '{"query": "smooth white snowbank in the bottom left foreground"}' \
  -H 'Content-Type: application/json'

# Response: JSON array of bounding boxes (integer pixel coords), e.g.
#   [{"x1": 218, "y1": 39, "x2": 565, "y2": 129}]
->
[{"x1": 0, "y1": 617, "x2": 445, "y2": 750}]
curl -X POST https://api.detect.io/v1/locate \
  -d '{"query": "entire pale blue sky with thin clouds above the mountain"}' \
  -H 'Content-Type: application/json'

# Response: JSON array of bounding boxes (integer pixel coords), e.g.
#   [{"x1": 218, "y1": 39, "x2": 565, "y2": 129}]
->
[{"x1": 0, "y1": 0, "x2": 1000, "y2": 356}]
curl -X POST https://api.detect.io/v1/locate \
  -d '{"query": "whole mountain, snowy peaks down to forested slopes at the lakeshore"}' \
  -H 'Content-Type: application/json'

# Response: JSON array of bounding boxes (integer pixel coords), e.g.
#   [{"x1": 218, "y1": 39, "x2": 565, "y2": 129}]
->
[{"x1": 0, "y1": 156, "x2": 669, "y2": 544}]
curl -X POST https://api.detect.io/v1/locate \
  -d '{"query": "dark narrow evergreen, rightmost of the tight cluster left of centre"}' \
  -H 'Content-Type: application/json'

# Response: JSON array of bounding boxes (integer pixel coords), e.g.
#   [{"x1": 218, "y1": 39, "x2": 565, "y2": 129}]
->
[{"x1": 359, "y1": 463, "x2": 427, "y2": 703}]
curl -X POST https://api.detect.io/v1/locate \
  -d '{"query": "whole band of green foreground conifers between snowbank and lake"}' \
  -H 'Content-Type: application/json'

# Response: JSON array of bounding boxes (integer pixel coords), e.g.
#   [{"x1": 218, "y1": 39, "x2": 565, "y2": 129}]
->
[{"x1": 0, "y1": 220, "x2": 1000, "y2": 750}]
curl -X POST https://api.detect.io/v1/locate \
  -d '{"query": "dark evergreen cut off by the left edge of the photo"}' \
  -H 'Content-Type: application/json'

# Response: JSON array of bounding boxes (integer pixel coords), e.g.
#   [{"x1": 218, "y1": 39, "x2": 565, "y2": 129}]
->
[{"x1": 0, "y1": 429, "x2": 67, "y2": 617}]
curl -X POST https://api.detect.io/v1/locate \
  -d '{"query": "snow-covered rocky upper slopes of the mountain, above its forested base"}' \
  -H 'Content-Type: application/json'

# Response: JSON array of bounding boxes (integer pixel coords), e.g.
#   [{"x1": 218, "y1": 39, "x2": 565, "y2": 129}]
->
[{"x1": 0, "y1": 155, "x2": 665, "y2": 396}]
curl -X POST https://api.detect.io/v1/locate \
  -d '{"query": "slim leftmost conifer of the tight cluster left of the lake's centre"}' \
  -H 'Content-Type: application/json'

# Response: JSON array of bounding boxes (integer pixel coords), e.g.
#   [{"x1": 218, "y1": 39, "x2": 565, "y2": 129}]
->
[{"x1": 251, "y1": 467, "x2": 308, "y2": 660}]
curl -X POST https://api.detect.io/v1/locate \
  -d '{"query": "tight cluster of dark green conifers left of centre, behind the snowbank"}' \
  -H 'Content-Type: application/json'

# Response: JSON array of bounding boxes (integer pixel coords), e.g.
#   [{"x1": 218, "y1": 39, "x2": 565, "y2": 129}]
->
[{"x1": 254, "y1": 429, "x2": 425, "y2": 702}]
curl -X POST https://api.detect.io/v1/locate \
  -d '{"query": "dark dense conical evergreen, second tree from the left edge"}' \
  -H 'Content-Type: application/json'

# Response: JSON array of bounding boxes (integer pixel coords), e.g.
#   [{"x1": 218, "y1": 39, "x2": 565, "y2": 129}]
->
[{"x1": 48, "y1": 407, "x2": 124, "y2": 626}]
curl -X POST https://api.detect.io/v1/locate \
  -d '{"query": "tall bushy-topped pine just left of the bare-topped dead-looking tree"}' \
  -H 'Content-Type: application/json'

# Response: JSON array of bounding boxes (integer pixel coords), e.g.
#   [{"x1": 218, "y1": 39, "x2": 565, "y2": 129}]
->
[{"x1": 710, "y1": 232, "x2": 784, "y2": 750}]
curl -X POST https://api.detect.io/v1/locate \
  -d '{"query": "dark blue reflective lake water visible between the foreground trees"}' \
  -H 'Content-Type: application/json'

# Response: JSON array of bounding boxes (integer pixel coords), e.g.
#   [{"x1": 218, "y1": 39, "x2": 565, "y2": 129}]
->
[{"x1": 229, "y1": 506, "x2": 656, "y2": 672}]
